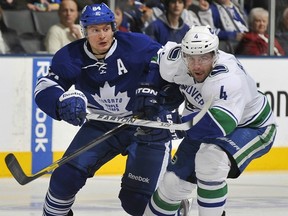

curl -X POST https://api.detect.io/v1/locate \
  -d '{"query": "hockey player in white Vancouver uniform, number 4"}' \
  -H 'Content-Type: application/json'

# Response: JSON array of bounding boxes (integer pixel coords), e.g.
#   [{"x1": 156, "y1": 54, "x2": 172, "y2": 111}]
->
[{"x1": 145, "y1": 26, "x2": 276, "y2": 216}]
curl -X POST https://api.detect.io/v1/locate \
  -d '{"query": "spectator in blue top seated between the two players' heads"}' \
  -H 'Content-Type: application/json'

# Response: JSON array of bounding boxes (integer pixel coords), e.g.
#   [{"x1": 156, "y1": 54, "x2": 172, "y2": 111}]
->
[{"x1": 145, "y1": 0, "x2": 189, "y2": 45}]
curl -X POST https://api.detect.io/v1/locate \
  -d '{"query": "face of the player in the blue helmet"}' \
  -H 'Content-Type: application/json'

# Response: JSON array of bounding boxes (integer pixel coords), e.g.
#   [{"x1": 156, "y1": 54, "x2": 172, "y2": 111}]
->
[{"x1": 87, "y1": 23, "x2": 114, "y2": 54}]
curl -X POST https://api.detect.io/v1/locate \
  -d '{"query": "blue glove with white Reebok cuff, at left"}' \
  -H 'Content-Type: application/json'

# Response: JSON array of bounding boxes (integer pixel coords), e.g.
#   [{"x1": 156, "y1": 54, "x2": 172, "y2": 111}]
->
[{"x1": 57, "y1": 90, "x2": 87, "y2": 126}]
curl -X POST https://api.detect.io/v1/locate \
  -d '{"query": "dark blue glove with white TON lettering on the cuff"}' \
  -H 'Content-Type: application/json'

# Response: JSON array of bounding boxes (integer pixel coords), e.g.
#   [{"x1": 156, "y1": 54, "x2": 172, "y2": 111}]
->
[{"x1": 133, "y1": 83, "x2": 160, "y2": 120}]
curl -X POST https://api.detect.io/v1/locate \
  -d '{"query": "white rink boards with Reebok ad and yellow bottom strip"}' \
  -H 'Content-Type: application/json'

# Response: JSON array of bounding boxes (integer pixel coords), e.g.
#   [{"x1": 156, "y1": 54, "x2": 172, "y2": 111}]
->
[{"x1": 0, "y1": 56, "x2": 288, "y2": 177}]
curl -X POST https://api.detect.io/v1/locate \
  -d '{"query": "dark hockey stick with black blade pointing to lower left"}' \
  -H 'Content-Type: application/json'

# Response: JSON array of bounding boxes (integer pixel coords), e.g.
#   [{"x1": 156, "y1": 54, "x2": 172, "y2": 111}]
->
[{"x1": 5, "y1": 124, "x2": 128, "y2": 185}]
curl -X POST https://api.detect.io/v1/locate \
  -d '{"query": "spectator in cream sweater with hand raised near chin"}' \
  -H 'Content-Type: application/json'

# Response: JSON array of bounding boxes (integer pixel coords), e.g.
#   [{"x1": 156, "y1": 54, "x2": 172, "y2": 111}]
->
[{"x1": 45, "y1": 0, "x2": 83, "y2": 54}]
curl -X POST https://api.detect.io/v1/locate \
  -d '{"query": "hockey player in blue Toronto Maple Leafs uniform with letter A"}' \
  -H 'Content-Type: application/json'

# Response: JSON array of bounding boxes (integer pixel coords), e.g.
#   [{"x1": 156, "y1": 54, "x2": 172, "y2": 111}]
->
[{"x1": 35, "y1": 3, "x2": 179, "y2": 216}]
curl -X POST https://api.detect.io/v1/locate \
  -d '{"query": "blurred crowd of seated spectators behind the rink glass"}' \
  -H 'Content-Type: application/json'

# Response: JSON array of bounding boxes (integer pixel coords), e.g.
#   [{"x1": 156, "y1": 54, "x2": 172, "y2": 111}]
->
[{"x1": 0, "y1": 0, "x2": 288, "y2": 56}]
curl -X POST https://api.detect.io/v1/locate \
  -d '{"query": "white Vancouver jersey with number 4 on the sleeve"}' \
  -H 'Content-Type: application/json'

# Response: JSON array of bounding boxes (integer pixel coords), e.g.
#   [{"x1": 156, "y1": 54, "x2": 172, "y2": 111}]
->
[{"x1": 158, "y1": 42, "x2": 275, "y2": 131}]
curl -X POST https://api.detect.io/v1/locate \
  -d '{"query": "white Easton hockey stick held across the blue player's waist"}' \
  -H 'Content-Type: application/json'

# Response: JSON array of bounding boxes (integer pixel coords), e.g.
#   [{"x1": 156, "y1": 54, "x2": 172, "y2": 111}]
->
[{"x1": 86, "y1": 100, "x2": 212, "y2": 131}]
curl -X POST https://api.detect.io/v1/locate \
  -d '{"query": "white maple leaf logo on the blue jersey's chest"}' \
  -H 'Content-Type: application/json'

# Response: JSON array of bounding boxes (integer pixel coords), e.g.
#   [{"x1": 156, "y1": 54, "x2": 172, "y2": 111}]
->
[{"x1": 92, "y1": 82, "x2": 130, "y2": 115}]
